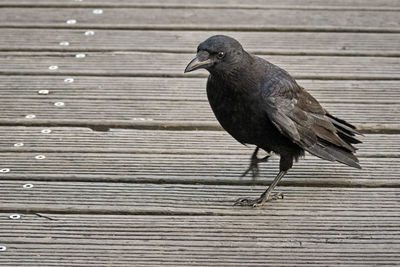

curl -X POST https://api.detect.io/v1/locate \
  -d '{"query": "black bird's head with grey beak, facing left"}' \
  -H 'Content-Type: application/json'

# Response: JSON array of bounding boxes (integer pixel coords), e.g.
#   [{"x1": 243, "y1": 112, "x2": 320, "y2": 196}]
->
[{"x1": 185, "y1": 35, "x2": 245, "y2": 73}]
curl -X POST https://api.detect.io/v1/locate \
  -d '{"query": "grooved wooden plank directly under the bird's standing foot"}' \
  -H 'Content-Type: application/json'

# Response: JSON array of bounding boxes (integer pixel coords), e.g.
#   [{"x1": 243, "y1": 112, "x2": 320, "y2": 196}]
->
[{"x1": 0, "y1": 180, "x2": 400, "y2": 217}]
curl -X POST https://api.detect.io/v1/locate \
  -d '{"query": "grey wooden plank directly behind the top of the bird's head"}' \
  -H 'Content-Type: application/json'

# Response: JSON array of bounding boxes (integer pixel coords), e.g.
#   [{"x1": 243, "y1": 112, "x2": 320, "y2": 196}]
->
[{"x1": 0, "y1": 28, "x2": 400, "y2": 56}]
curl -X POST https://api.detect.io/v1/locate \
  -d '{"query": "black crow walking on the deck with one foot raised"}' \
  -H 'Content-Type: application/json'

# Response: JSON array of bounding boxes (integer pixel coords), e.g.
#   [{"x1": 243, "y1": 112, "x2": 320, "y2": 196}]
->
[{"x1": 185, "y1": 35, "x2": 361, "y2": 207}]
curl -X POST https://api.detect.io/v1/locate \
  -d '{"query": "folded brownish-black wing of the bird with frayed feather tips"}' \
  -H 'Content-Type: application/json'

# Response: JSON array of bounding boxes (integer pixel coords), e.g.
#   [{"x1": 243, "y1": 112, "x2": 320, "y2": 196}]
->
[{"x1": 263, "y1": 75, "x2": 360, "y2": 168}]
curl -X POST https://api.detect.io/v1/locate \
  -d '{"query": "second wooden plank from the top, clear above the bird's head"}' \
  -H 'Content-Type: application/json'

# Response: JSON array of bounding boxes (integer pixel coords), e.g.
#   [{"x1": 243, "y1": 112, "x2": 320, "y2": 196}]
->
[{"x1": 0, "y1": 7, "x2": 400, "y2": 32}]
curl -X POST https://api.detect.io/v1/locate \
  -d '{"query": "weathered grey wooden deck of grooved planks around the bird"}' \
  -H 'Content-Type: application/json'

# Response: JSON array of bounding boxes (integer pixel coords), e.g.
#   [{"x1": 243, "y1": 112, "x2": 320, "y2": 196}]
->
[{"x1": 0, "y1": 0, "x2": 400, "y2": 266}]
